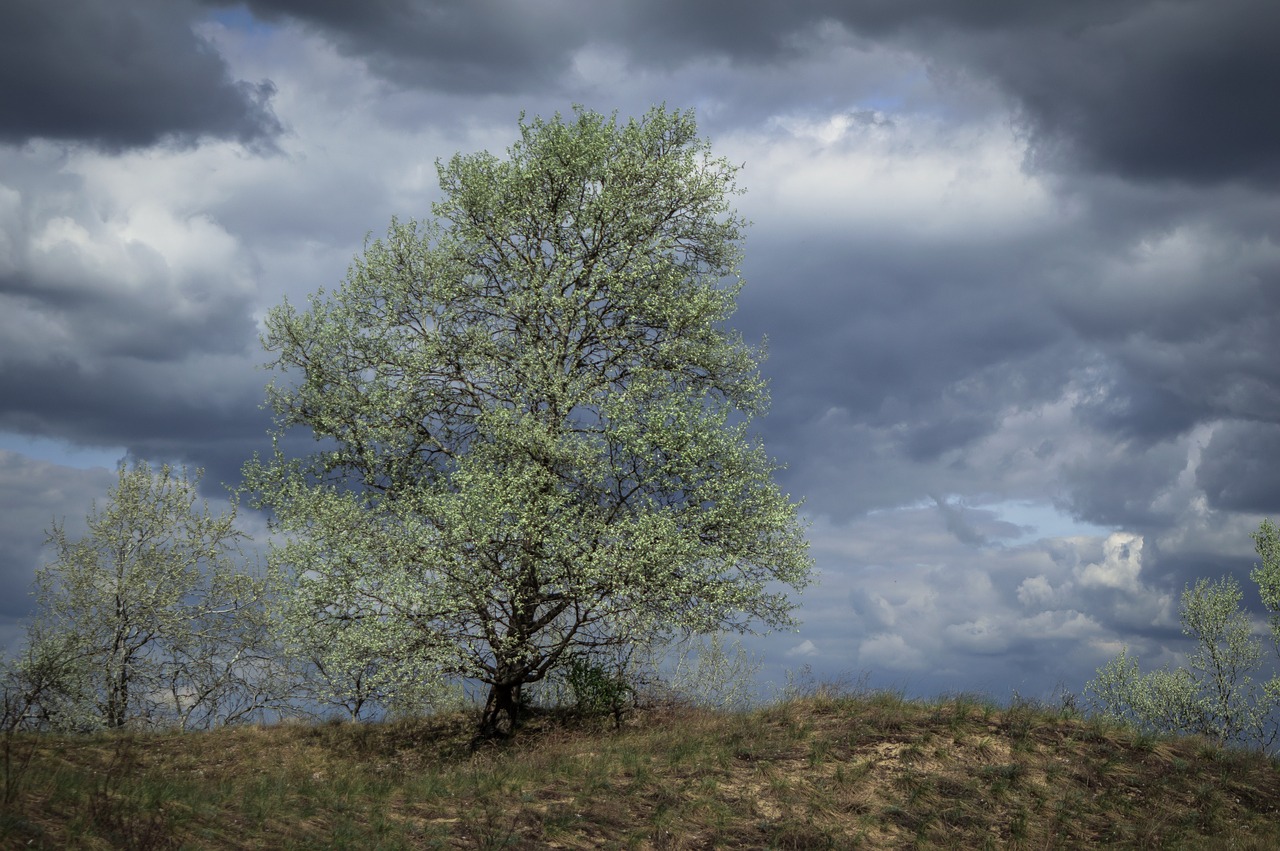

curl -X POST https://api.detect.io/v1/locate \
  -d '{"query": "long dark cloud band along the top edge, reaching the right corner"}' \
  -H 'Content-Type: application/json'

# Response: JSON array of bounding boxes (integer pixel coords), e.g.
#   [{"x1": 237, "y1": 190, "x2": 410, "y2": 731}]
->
[{"x1": 207, "y1": 0, "x2": 1280, "y2": 184}]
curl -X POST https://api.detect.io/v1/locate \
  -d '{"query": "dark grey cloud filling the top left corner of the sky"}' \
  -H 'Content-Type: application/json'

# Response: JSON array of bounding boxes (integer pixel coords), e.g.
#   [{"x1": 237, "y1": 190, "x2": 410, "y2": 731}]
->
[{"x1": 0, "y1": 0, "x2": 280, "y2": 150}]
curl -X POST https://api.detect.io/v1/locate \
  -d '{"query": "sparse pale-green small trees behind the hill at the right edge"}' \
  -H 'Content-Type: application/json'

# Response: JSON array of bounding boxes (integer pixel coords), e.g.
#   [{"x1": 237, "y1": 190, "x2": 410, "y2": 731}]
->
[{"x1": 1085, "y1": 521, "x2": 1280, "y2": 750}]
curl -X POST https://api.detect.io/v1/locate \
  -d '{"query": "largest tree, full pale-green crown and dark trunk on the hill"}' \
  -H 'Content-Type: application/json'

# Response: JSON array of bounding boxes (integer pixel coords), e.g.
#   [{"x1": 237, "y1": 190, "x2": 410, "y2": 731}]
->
[{"x1": 246, "y1": 107, "x2": 812, "y2": 736}]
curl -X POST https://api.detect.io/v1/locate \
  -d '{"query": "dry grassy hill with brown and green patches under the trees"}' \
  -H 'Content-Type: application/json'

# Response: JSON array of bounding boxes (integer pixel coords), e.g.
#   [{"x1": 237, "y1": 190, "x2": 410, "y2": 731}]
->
[{"x1": 0, "y1": 691, "x2": 1280, "y2": 850}]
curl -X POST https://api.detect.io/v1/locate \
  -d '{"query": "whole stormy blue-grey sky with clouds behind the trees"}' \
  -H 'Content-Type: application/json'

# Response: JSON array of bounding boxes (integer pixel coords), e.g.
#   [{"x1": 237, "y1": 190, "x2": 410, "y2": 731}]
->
[{"x1": 0, "y1": 0, "x2": 1280, "y2": 699}]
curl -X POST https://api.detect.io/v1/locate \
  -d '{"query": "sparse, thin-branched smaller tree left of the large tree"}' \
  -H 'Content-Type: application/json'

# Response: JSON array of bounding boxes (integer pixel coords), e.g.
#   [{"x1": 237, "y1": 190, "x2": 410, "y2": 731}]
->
[{"x1": 6, "y1": 463, "x2": 274, "y2": 728}]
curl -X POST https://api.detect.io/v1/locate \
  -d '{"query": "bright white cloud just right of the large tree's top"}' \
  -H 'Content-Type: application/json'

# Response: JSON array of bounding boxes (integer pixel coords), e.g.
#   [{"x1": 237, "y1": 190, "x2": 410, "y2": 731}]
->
[{"x1": 732, "y1": 111, "x2": 1064, "y2": 246}]
